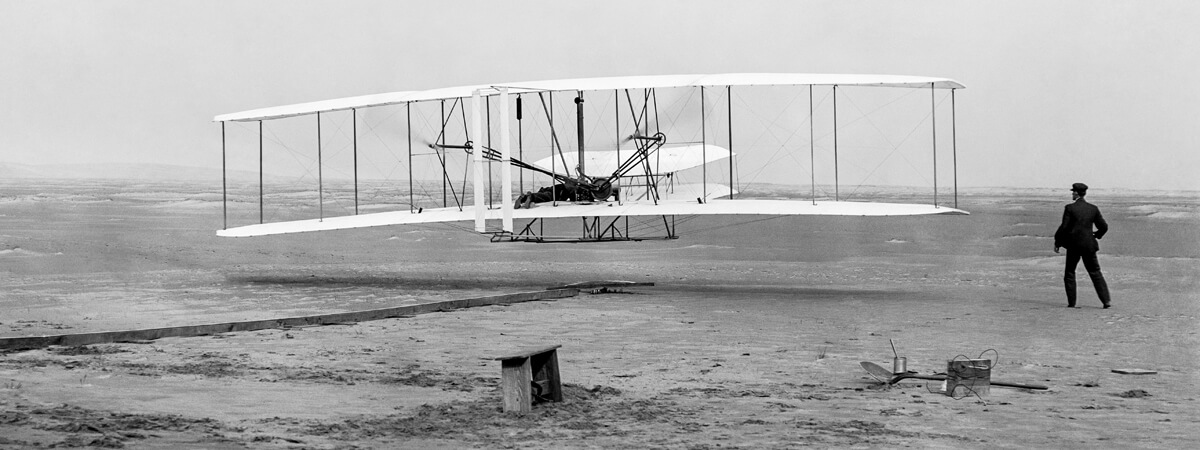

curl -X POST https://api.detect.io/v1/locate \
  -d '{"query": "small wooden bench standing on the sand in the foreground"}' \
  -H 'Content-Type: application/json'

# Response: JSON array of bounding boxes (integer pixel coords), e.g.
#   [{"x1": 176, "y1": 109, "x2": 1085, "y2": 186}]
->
[{"x1": 494, "y1": 346, "x2": 563, "y2": 414}]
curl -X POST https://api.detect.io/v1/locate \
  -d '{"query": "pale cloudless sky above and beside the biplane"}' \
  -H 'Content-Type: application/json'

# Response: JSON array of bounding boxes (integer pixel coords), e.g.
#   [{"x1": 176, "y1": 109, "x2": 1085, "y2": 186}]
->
[{"x1": 0, "y1": 0, "x2": 1200, "y2": 191}]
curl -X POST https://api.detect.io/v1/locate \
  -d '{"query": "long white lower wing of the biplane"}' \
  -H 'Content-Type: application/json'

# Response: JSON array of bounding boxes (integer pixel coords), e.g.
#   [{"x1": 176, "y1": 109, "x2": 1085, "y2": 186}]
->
[{"x1": 217, "y1": 199, "x2": 968, "y2": 238}]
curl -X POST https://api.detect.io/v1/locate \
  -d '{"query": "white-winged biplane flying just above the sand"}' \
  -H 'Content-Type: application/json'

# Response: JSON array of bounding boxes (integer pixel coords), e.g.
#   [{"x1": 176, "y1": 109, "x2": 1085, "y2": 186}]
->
[{"x1": 214, "y1": 73, "x2": 967, "y2": 242}]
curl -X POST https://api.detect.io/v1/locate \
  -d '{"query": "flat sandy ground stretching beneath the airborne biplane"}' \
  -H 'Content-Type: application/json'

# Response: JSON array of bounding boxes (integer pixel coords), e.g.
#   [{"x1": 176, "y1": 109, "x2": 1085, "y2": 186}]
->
[{"x1": 0, "y1": 182, "x2": 1200, "y2": 449}]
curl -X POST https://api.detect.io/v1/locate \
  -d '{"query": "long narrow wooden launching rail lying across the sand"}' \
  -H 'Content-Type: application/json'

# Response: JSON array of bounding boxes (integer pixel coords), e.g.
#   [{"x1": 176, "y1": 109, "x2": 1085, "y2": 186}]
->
[{"x1": 0, "y1": 289, "x2": 580, "y2": 350}]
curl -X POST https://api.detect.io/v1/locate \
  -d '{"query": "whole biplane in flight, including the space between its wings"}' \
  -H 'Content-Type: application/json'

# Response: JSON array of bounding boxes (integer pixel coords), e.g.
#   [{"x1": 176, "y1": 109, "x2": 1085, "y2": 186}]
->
[{"x1": 214, "y1": 73, "x2": 966, "y2": 242}]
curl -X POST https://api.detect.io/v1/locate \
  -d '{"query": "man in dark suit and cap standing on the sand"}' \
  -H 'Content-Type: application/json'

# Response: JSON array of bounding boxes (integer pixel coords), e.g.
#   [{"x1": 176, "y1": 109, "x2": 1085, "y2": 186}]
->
[{"x1": 1054, "y1": 182, "x2": 1112, "y2": 307}]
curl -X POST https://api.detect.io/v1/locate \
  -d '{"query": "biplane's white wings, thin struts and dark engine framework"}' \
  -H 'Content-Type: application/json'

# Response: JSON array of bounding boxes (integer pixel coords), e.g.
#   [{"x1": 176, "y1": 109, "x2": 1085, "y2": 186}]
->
[{"x1": 214, "y1": 73, "x2": 966, "y2": 242}]
